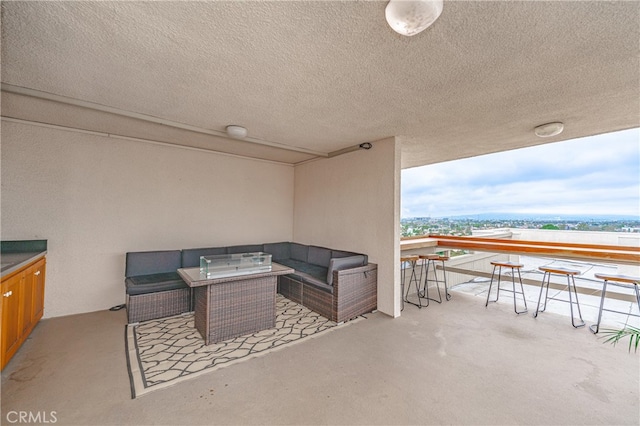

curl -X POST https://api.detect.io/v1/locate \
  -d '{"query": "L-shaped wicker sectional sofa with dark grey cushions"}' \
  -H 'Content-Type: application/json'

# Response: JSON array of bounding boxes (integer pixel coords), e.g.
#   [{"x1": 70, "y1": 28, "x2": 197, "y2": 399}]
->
[{"x1": 125, "y1": 242, "x2": 377, "y2": 323}]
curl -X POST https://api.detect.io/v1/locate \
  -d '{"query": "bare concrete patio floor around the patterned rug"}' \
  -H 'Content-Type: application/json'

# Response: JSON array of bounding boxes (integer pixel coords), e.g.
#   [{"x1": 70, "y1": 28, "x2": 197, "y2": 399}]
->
[{"x1": 1, "y1": 291, "x2": 640, "y2": 425}]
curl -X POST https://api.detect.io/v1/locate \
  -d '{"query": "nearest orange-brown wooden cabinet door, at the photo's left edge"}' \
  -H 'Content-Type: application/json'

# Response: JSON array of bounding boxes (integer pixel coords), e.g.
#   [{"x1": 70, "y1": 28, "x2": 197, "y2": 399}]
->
[{"x1": 1, "y1": 272, "x2": 25, "y2": 368}]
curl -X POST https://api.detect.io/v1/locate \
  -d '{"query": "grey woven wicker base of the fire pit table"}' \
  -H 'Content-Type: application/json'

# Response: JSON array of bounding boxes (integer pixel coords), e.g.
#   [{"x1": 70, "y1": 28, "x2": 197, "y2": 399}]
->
[{"x1": 196, "y1": 276, "x2": 277, "y2": 344}]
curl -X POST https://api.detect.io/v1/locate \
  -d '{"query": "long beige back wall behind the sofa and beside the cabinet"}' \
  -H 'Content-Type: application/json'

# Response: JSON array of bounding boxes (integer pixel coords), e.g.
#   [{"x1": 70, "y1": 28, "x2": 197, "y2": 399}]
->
[{"x1": 1, "y1": 120, "x2": 294, "y2": 317}]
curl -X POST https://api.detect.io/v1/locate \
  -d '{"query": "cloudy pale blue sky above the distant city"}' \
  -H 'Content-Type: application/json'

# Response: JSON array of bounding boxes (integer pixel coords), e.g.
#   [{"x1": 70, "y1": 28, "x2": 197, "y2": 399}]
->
[{"x1": 401, "y1": 128, "x2": 640, "y2": 220}]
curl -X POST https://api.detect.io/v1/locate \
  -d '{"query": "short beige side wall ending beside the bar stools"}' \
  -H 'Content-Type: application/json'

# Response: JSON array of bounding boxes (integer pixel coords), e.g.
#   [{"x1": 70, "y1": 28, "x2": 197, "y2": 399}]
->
[{"x1": 293, "y1": 138, "x2": 400, "y2": 316}]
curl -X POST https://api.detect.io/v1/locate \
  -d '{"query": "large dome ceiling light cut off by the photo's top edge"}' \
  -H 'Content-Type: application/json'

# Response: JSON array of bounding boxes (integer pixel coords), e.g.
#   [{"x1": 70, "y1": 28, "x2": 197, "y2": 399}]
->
[{"x1": 384, "y1": 0, "x2": 444, "y2": 36}]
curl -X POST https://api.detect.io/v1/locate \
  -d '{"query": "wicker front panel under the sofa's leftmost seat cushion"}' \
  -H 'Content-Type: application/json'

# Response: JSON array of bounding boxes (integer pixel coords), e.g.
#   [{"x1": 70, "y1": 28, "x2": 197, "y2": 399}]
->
[{"x1": 127, "y1": 288, "x2": 192, "y2": 324}]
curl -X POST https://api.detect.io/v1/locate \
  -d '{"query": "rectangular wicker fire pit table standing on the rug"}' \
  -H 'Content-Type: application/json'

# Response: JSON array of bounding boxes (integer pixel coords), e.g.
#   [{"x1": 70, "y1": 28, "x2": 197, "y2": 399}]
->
[{"x1": 178, "y1": 263, "x2": 294, "y2": 345}]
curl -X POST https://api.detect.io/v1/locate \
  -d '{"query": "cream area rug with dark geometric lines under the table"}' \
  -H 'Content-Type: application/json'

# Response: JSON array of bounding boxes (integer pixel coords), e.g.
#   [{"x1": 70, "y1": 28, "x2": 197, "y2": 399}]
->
[{"x1": 125, "y1": 294, "x2": 364, "y2": 399}]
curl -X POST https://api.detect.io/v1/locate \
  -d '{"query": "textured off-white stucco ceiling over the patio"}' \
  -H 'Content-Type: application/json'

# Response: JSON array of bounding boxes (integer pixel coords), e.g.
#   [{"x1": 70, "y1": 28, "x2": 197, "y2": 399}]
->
[{"x1": 2, "y1": 0, "x2": 640, "y2": 167}]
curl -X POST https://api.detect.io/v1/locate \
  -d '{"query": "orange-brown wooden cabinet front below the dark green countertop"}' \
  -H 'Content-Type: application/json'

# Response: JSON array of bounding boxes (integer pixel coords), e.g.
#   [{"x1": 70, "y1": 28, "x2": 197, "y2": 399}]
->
[{"x1": 0, "y1": 258, "x2": 46, "y2": 368}]
